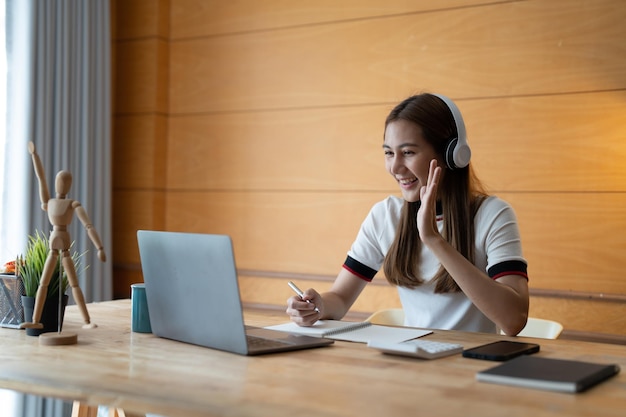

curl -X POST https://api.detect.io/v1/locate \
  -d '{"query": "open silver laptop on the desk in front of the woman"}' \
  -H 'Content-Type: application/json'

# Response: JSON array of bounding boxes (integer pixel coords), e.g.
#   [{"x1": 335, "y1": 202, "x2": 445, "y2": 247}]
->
[{"x1": 137, "y1": 230, "x2": 333, "y2": 355}]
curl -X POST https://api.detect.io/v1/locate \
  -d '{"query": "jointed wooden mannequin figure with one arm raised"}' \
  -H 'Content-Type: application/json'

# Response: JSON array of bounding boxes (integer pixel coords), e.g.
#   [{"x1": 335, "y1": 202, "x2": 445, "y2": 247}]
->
[{"x1": 20, "y1": 142, "x2": 106, "y2": 344}]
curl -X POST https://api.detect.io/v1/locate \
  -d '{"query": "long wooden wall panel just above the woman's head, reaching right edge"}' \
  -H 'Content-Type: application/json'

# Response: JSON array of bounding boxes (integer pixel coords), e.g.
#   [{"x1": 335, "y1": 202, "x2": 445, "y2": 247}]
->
[{"x1": 170, "y1": 0, "x2": 626, "y2": 114}]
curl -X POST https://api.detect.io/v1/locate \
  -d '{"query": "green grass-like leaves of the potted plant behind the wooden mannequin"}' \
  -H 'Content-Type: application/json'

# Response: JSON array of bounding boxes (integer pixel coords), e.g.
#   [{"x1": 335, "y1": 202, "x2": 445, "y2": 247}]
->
[{"x1": 15, "y1": 231, "x2": 83, "y2": 298}]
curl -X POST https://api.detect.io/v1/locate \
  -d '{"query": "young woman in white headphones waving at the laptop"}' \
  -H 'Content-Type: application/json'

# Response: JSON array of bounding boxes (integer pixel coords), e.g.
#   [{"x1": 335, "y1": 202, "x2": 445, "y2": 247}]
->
[{"x1": 286, "y1": 94, "x2": 528, "y2": 335}]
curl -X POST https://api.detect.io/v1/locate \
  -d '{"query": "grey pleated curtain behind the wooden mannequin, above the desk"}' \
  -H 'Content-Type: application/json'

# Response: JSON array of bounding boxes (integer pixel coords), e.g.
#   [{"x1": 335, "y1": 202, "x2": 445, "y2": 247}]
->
[{"x1": 29, "y1": 0, "x2": 112, "y2": 302}]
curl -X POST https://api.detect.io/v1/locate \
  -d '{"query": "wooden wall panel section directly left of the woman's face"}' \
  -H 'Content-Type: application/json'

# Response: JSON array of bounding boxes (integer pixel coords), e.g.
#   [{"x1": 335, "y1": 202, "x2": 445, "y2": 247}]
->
[{"x1": 167, "y1": 106, "x2": 396, "y2": 191}]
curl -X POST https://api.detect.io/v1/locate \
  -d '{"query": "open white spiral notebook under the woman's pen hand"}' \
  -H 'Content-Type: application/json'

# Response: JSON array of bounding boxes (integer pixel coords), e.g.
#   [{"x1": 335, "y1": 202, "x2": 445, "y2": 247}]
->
[{"x1": 266, "y1": 320, "x2": 432, "y2": 343}]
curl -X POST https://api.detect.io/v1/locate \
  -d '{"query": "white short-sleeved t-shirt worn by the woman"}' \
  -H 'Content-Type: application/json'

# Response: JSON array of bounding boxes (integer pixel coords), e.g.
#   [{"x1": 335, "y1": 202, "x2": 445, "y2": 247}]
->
[{"x1": 344, "y1": 196, "x2": 526, "y2": 333}]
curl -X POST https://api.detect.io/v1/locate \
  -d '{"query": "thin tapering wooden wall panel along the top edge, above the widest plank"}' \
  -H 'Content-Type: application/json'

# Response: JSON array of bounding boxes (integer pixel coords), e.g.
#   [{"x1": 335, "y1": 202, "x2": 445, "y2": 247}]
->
[{"x1": 171, "y1": 0, "x2": 492, "y2": 39}]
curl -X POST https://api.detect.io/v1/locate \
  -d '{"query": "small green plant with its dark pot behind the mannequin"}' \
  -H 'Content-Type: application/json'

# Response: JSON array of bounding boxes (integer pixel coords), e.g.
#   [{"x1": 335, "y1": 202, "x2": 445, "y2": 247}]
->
[{"x1": 16, "y1": 231, "x2": 82, "y2": 336}]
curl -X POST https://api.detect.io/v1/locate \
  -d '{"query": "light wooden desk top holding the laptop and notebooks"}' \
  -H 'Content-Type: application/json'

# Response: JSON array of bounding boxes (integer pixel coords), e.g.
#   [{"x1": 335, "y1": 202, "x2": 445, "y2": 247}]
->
[{"x1": 0, "y1": 300, "x2": 626, "y2": 417}]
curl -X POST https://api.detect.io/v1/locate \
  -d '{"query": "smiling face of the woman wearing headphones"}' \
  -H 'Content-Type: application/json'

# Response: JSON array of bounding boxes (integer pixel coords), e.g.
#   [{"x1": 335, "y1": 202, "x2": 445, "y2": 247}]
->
[{"x1": 383, "y1": 119, "x2": 445, "y2": 202}]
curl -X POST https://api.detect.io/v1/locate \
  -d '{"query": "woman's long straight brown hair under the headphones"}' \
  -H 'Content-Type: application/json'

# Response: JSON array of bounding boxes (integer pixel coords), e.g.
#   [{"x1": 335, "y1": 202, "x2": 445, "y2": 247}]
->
[{"x1": 383, "y1": 94, "x2": 486, "y2": 293}]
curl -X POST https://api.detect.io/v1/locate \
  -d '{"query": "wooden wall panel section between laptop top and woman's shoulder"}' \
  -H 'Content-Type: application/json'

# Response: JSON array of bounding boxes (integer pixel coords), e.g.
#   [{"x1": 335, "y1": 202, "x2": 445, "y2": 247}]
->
[{"x1": 166, "y1": 191, "x2": 384, "y2": 275}]
